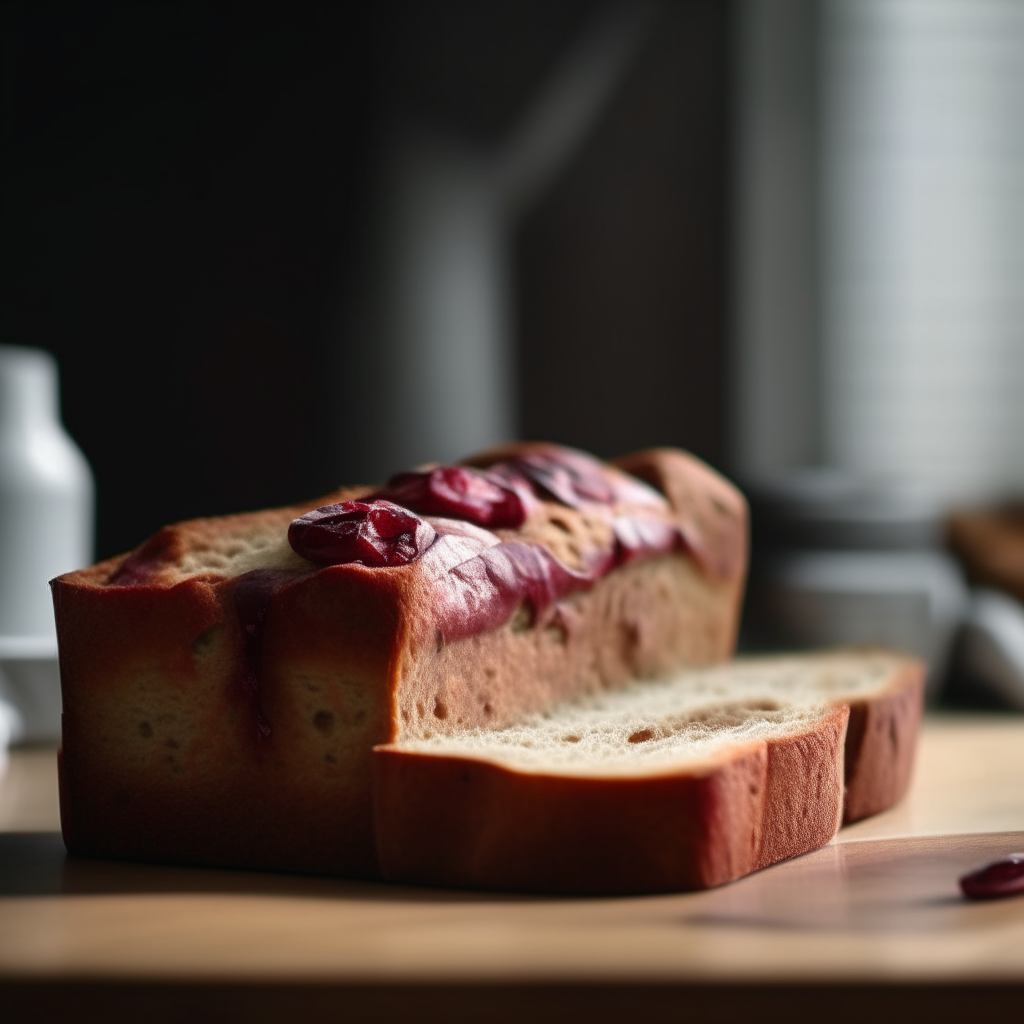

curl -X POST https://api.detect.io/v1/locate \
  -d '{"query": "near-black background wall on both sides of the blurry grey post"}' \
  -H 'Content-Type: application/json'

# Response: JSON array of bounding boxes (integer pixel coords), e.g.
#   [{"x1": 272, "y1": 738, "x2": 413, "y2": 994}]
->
[{"x1": 0, "y1": 0, "x2": 728, "y2": 556}]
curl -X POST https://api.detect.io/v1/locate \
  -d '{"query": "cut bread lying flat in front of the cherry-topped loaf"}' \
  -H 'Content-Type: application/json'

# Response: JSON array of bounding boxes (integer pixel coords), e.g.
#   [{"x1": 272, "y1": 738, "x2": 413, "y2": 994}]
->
[{"x1": 374, "y1": 651, "x2": 924, "y2": 893}]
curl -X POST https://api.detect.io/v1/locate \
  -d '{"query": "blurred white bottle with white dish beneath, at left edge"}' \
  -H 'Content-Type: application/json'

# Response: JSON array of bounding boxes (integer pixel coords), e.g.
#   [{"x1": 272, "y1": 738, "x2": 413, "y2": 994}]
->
[{"x1": 0, "y1": 345, "x2": 94, "y2": 741}]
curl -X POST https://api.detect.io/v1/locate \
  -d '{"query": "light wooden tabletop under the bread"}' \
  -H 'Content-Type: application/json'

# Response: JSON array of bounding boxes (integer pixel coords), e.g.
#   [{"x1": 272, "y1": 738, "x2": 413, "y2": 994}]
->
[{"x1": 0, "y1": 715, "x2": 1024, "y2": 1024}]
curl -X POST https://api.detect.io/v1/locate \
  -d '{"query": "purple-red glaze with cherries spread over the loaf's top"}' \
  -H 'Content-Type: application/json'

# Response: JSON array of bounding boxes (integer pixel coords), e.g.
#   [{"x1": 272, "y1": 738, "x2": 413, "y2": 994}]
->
[{"x1": 289, "y1": 445, "x2": 682, "y2": 640}]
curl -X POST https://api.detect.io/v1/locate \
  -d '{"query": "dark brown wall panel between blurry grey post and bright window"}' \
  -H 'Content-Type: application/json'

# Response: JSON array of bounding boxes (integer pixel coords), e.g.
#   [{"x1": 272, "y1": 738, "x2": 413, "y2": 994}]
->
[{"x1": 516, "y1": 2, "x2": 730, "y2": 466}]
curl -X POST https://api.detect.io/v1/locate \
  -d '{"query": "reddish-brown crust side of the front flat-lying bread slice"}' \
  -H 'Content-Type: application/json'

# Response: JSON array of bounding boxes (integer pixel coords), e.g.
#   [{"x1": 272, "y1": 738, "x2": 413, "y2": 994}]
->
[{"x1": 374, "y1": 707, "x2": 847, "y2": 894}]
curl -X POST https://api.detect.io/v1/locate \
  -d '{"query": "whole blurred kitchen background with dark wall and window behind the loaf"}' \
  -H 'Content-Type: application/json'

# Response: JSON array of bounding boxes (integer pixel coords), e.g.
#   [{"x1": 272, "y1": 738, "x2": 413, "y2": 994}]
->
[{"x1": 0, "y1": 0, "x2": 1024, "y2": 729}]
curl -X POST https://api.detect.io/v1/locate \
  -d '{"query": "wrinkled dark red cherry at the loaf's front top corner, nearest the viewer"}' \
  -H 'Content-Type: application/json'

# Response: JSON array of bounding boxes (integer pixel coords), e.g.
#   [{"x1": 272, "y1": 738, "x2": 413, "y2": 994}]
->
[{"x1": 288, "y1": 499, "x2": 435, "y2": 567}]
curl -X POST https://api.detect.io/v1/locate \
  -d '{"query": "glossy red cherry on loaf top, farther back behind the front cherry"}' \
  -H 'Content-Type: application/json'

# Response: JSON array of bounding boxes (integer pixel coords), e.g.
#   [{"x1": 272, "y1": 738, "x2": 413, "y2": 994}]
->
[{"x1": 374, "y1": 466, "x2": 526, "y2": 529}]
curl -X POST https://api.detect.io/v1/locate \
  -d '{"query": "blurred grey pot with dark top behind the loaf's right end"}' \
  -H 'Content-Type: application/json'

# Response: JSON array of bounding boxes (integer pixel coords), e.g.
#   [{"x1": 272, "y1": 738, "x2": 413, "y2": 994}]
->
[{"x1": 749, "y1": 470, "x2": 969, "y2": 697}]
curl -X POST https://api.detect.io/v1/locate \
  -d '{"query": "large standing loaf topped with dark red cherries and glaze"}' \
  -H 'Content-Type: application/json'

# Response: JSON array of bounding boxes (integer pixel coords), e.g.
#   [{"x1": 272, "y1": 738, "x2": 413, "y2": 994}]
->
[{"x1": 53, "y1": 444, "x2": 749, "y2": 877}]
